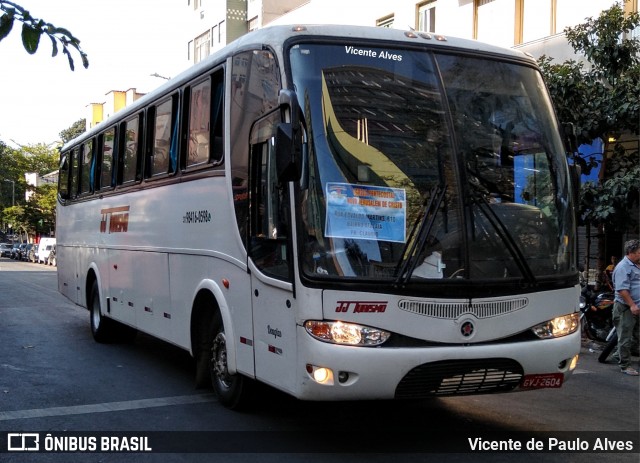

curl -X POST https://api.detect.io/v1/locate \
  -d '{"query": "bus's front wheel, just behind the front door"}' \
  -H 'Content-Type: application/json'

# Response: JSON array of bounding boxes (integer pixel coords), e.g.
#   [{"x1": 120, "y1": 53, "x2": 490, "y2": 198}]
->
[{"x1": 209, "y1": 312, "x2": 253, "y2": 410}]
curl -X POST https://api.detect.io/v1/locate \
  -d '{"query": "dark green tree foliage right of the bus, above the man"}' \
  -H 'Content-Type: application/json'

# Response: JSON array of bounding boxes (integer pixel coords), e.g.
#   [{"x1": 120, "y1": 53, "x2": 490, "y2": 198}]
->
[{"x1": 538, "y1": 3, "x2": 640, "y2": 230}]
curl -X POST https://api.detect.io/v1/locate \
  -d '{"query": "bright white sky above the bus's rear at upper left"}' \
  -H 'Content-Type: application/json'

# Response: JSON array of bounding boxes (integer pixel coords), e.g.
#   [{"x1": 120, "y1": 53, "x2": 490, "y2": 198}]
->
[{"x1": 0, "y1": 0, "x2": 187, "y2": 147}]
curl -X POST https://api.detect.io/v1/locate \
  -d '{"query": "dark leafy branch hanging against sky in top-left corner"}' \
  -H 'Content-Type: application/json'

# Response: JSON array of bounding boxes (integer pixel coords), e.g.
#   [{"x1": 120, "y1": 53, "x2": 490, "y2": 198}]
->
[{"x1": 0, "y1": 0, "x2": 89, "y2": 71}]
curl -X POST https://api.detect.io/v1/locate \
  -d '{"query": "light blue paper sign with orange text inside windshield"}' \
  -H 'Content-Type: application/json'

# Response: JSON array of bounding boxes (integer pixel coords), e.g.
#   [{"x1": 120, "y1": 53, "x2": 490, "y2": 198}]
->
[{"x1": 325, "y1": 183, "x2": 407, "y2": 243}]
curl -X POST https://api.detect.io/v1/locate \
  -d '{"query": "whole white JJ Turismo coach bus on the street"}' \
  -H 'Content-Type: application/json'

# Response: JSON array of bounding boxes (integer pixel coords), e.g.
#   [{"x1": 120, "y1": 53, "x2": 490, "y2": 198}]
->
[{"x1": 57, "y1": 26, "x2": 580, "y2": 408}]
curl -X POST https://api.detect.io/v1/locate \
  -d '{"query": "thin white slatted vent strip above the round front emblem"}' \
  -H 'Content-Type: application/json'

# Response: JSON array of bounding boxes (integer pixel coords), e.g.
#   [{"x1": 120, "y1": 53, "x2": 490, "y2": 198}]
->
[{"x1": 398, "y1": 297, "x2": 529, "y2": 320}]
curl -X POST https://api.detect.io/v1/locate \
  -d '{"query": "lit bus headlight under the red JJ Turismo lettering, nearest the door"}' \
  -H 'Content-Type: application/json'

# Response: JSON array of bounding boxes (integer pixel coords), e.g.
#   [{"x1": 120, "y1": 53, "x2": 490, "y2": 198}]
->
[{"x1": 304, "y1": 320, "x2": 391, "y2": 346}]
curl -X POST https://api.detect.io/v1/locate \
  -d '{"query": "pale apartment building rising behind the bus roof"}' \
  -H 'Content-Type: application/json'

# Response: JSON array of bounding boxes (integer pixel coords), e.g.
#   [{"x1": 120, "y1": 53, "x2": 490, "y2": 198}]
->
[{"x1": 186, "y1": 0, "x2": 638, "y2": 64}]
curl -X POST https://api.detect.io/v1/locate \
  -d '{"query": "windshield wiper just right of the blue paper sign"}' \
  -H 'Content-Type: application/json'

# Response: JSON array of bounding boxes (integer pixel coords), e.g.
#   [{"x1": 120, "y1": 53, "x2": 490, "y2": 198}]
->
[{"x1": 393, "y1": 185, "x2": 447, "y2": 287}]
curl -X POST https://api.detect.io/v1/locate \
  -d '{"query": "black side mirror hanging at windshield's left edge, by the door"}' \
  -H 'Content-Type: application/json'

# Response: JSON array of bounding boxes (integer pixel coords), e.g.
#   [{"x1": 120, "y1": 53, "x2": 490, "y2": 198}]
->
[{"x1": 275, "y1": 89, "x2": 302, "y2": 183}]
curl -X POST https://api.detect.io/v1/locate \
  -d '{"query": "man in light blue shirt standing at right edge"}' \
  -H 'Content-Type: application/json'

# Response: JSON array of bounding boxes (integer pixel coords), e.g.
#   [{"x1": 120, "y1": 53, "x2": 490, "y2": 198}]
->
[{"x1": 613, "y1": 240, "x2": 640, "y2": 376}]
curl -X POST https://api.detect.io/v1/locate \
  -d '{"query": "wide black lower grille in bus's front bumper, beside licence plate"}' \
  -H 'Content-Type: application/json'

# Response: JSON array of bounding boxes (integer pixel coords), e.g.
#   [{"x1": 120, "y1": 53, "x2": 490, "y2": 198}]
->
[{"x1": 395, "y1": 358, "x2": 524, "y2": 399}]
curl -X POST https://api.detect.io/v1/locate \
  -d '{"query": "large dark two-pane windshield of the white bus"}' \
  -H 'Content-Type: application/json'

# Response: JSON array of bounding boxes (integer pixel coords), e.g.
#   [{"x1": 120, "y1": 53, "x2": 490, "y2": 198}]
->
[{"x1": 289, "y1": 43, "x2": 575, "y2": 284}]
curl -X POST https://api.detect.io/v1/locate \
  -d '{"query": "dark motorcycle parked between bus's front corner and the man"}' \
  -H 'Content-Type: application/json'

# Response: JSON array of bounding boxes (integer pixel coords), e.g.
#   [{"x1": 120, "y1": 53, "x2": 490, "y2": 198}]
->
[{"x1": 580, "y1": 286, "x2": 617, "y2": 349}]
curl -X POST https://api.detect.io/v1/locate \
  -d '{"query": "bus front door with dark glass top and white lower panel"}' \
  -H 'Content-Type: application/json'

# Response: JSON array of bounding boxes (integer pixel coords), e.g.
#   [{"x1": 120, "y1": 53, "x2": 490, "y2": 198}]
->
[{"x1": 249, "y1": 138, "x2": 296, "y2": 391}]
